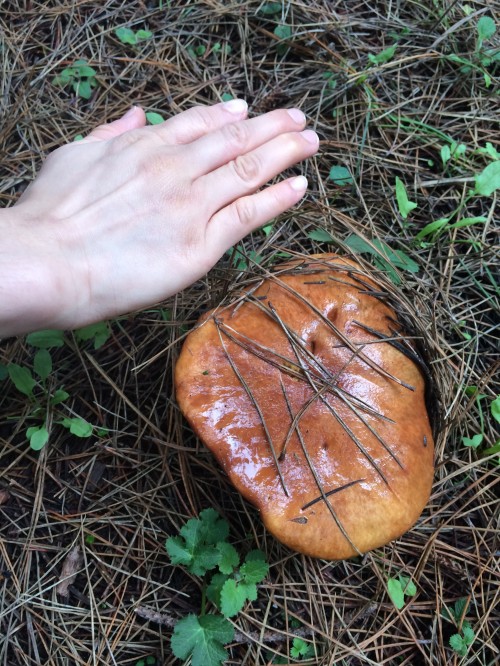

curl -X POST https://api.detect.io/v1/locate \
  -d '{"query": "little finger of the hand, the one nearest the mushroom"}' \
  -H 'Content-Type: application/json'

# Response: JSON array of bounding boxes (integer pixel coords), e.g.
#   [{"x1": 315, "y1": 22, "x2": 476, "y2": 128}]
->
[{"x1": 206, "y1": 176, "x2": 307, "y2": 259}]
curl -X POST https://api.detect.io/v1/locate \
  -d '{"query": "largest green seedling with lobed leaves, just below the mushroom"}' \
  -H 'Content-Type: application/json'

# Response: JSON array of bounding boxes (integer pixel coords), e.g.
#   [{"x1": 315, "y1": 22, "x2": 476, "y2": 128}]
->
[{"x1": 165, "y1": 509, "x2": 269, "y2": 666}]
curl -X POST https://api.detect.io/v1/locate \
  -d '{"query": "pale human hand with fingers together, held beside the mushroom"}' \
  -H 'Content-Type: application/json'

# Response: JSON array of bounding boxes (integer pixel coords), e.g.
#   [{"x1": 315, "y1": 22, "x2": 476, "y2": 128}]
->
[{"x1": 0, "y1": 100, "x2": 318, "y2": 335}]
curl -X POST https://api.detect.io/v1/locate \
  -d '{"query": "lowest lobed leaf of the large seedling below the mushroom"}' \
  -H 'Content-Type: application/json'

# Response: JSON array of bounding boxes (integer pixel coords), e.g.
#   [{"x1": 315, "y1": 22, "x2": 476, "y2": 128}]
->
[{"x1": 171, "y1": 615, "x2": 234, "y2": 666}]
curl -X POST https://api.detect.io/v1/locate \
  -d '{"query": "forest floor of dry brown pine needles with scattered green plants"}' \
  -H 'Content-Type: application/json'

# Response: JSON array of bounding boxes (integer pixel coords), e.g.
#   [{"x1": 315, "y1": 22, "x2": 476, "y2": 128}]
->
[{"x1": 0, "y1": 0, "x2": 500, "y2": 666}]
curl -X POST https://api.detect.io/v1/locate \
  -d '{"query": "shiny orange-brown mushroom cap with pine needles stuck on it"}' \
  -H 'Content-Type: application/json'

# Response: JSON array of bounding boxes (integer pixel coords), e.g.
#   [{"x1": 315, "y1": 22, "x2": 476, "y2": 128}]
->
[{"x1": 175, "y1": 254, "x2": 434, "y2": 559}]
